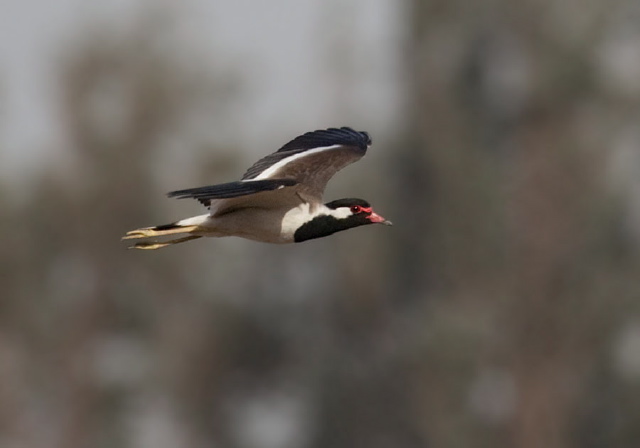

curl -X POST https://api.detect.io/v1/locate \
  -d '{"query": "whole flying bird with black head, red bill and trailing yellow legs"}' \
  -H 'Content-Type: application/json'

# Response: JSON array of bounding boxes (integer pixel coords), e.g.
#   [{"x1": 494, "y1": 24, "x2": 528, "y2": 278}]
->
[{"x1": 122, "y1": 127, "x2": 391, "y2": 249}]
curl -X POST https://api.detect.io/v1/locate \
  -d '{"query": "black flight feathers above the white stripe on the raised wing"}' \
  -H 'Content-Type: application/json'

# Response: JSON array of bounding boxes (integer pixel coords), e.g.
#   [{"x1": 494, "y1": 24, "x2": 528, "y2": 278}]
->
[{"x1": 242, "y1": 127, "x2": 371, "y2": 179}]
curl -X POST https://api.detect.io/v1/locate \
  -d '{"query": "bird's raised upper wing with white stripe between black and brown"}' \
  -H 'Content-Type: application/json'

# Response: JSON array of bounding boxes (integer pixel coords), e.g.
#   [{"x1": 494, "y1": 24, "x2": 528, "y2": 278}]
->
[{"x1": 242, "y1": 127, "x2": 371, "y2": 200}]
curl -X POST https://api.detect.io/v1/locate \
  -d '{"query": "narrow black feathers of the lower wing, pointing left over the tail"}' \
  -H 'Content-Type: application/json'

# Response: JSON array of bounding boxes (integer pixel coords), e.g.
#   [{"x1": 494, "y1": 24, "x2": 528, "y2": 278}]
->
[{"x1": 167, "y1": 179, "x2": 297, "y2": 205}]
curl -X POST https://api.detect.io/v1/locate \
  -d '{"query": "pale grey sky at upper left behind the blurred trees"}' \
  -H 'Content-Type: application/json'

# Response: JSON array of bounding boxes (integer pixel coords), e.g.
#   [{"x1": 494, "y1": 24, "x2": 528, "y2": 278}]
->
[{"x1": 0, "y1": 0, "x2": 401, "y2": 181}]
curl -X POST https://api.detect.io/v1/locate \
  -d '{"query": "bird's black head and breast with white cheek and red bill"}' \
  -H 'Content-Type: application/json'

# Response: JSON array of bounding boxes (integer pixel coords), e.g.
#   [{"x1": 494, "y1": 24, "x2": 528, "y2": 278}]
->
[{"x1": 294, "y1": 198, "x2": 391, "y2": 243}]
